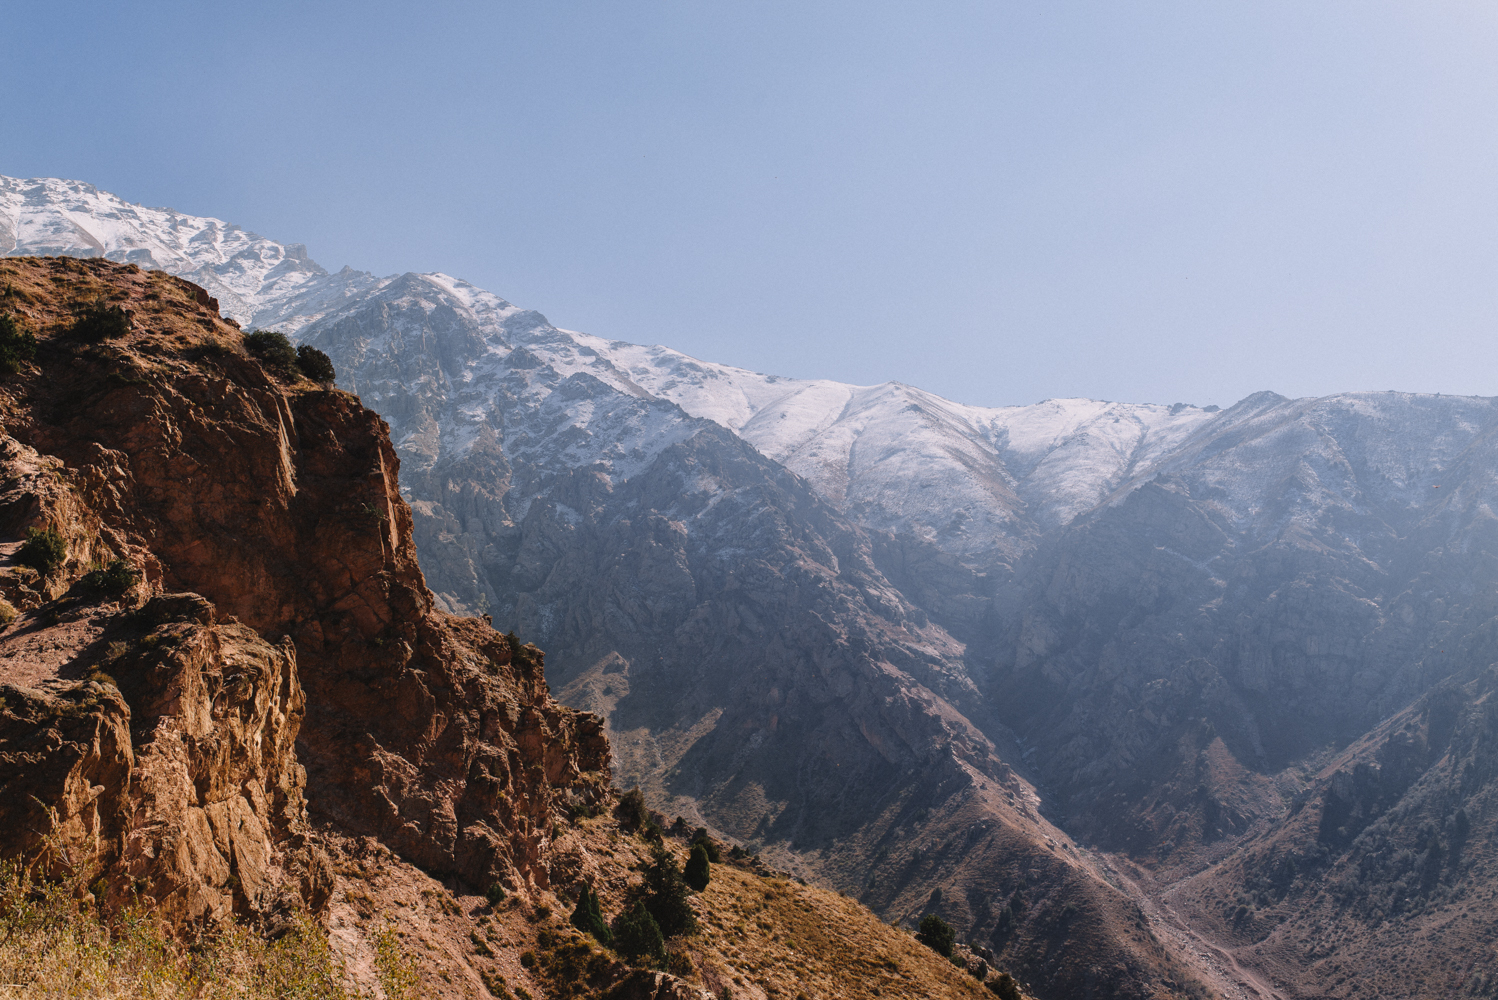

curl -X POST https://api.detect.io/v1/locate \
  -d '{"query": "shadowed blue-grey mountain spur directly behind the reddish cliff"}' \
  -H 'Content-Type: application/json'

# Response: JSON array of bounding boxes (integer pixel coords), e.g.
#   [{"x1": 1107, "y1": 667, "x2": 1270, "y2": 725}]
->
[{"x1": 289, "y1": 275, "x2": 1204, "y2": 997}]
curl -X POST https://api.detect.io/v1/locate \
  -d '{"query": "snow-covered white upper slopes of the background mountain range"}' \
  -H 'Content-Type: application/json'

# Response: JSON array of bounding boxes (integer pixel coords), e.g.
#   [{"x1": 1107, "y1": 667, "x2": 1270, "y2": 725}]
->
[{"x1": 0, "y1": 178, "x2": 1212, "y2": 561}]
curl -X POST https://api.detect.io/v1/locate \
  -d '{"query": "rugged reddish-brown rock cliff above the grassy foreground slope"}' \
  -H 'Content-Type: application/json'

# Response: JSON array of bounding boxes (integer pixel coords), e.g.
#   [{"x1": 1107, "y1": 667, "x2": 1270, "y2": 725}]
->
[{"x1": 0, "y1": 259, "x2": 608, "y2": 916}]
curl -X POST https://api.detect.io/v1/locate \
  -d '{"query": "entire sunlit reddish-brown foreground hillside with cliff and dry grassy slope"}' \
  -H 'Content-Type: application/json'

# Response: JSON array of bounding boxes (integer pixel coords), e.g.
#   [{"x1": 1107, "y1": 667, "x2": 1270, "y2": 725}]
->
[{"x1": 0, "y1": 257, "x2": 1042, "y2": 1000}]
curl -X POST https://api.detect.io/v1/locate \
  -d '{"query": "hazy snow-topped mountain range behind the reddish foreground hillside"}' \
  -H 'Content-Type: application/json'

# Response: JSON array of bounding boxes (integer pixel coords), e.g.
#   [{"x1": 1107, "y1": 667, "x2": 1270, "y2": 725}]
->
[{"x1": 0, "y1": 178, "x2": 1498, "y2": 997}]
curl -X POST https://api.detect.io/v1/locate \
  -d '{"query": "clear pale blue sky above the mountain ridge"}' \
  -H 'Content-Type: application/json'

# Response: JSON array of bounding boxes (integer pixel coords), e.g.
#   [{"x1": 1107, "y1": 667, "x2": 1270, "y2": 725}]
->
[{"x1": 0, "y1": 0, "x2": 1498, "y2": 406}]
